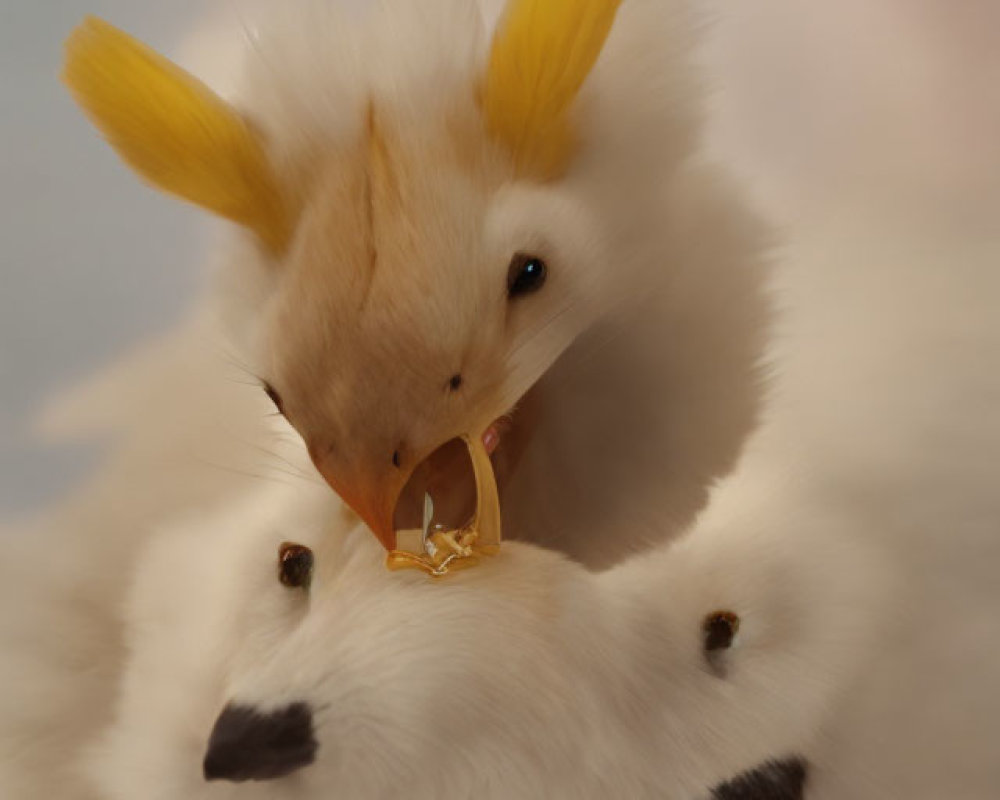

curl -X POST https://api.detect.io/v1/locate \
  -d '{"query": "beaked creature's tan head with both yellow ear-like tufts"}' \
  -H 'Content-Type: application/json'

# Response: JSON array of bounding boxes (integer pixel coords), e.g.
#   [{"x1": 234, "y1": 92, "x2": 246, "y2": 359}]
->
[{"x1": 65, "y1": 0, "x2": 620, "y2": 547}]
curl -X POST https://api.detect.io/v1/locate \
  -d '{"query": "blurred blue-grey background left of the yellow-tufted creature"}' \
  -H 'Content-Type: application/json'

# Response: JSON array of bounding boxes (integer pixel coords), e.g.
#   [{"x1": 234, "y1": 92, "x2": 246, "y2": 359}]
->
[{"x1": 0, "y1": 0, "x2": 203, "y2": 516}]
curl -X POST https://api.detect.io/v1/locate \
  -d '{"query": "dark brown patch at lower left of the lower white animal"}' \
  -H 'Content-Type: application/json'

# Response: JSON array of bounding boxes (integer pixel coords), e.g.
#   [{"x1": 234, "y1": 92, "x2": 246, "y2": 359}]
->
[{"x1": 204, "y1": 703, "x2": 317, "y2": 781}]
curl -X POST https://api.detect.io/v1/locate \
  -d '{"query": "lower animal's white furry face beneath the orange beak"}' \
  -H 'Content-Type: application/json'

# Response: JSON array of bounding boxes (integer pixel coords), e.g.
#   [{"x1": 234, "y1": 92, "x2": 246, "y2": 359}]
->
[{"x1": 80, "y1": 478, "x2": 882, "y2": 798}]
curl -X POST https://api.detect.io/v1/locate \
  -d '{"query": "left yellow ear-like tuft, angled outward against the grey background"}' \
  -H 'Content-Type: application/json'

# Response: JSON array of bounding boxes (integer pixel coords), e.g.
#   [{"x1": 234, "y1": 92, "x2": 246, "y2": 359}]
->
[{"x1": 63, "y1": 17, "x2": 290, "y2": 252}]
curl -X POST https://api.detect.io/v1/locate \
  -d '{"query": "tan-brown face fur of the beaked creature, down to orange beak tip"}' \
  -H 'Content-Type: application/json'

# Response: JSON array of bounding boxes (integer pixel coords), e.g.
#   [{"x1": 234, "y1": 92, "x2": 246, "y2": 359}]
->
[{"x1": 261, "y1": 105, "x2": 524, "y2": 541}]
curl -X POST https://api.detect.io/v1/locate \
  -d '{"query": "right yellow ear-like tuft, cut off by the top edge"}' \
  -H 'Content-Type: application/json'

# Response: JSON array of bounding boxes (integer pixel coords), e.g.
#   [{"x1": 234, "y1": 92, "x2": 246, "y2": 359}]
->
[{"x1": 482, "y1": 0, "x2": 621, "y2": 178}]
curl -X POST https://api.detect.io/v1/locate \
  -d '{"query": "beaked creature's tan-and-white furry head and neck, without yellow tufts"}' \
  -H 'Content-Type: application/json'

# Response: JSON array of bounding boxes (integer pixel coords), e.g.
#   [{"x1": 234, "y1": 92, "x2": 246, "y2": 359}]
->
[{"x1": 211, "y1": 0, "x2": 768, "y2": 567}]
